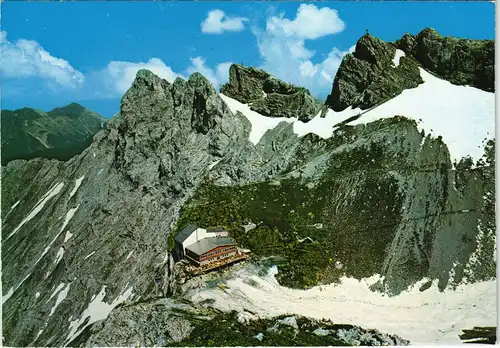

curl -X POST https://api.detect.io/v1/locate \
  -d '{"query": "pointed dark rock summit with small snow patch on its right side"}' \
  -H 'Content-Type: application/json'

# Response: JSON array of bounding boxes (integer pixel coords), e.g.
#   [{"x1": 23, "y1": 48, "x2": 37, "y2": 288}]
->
[{"x1": 326, "y1": 34, "x2": 423, "y2": 111}]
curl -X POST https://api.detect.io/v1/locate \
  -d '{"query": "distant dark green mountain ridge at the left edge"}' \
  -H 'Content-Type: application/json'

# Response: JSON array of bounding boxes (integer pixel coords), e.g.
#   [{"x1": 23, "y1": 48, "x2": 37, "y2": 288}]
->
[{"x1": 1, "y1": 103, "x2": 106, "y2": 165}]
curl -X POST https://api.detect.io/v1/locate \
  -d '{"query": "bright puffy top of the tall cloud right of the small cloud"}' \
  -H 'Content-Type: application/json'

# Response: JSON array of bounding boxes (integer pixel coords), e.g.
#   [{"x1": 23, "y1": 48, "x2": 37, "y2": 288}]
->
[{"x1": 266, "y1": 4, "x2": 345, "y2": 40}]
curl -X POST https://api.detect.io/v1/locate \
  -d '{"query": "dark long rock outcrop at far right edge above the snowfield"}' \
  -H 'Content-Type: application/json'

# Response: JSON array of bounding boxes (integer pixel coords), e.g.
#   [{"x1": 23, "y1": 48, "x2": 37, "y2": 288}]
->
[{"x1": 396, "y1": 28, "x2": 495, "y2": 92}]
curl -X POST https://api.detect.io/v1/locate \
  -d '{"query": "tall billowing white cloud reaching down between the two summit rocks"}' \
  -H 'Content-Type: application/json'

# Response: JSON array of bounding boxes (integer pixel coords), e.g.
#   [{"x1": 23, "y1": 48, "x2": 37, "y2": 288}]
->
[{"x1": 253, "y1": 4, "x2": 355, "y2": 97}]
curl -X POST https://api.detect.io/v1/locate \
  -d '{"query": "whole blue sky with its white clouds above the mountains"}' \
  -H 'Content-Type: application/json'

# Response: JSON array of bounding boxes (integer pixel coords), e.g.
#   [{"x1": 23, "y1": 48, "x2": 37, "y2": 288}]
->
[{"x1": 0, "y1": 1, "x2": 495, "y2": 117}]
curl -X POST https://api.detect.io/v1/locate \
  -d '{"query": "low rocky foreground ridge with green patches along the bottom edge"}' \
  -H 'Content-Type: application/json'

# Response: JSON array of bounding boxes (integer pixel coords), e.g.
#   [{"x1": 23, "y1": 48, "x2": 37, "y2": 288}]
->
[{"x1": 87, "y1": 299, "x2": 409, "y2": 347}]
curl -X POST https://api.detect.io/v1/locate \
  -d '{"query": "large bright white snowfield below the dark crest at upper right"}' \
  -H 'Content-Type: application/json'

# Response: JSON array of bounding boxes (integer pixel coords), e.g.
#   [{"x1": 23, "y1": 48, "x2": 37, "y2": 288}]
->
[{"x1": 350, "y1": 69, "x2": 495, "y2": 162}]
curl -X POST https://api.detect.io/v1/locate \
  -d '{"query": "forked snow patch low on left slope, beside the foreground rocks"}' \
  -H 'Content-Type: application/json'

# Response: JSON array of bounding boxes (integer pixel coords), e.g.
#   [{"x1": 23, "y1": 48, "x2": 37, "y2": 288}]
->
[{"x1": 64, "y1": 285, "x2": 133, "y2": 346}]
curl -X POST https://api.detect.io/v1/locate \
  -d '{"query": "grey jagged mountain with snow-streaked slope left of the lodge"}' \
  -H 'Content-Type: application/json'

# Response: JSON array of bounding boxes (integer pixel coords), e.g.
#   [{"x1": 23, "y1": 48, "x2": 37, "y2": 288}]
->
[{"x1": 2, "y1": 71, "x2": 254, "y2": 346}]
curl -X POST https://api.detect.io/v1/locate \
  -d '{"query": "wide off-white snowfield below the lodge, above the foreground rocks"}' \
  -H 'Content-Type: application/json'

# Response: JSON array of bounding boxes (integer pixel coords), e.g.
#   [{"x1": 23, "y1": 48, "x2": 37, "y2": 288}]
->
[{"x1": 187, "y1": 265, "x2": 497, "y2": 345}]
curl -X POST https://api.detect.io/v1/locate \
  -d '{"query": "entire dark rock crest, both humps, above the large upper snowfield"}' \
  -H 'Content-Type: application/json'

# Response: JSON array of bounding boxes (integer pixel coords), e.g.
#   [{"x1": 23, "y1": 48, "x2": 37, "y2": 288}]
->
[{"x1": 326, "y1": 28, "x2": 495, "y2": 111}]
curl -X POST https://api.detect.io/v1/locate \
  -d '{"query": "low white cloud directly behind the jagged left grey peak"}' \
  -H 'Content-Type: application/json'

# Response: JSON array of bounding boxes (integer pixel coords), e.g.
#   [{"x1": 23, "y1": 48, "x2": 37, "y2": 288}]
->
[{"x1": 102, "y1": 58, "x2": 185, "y2": 94}]
